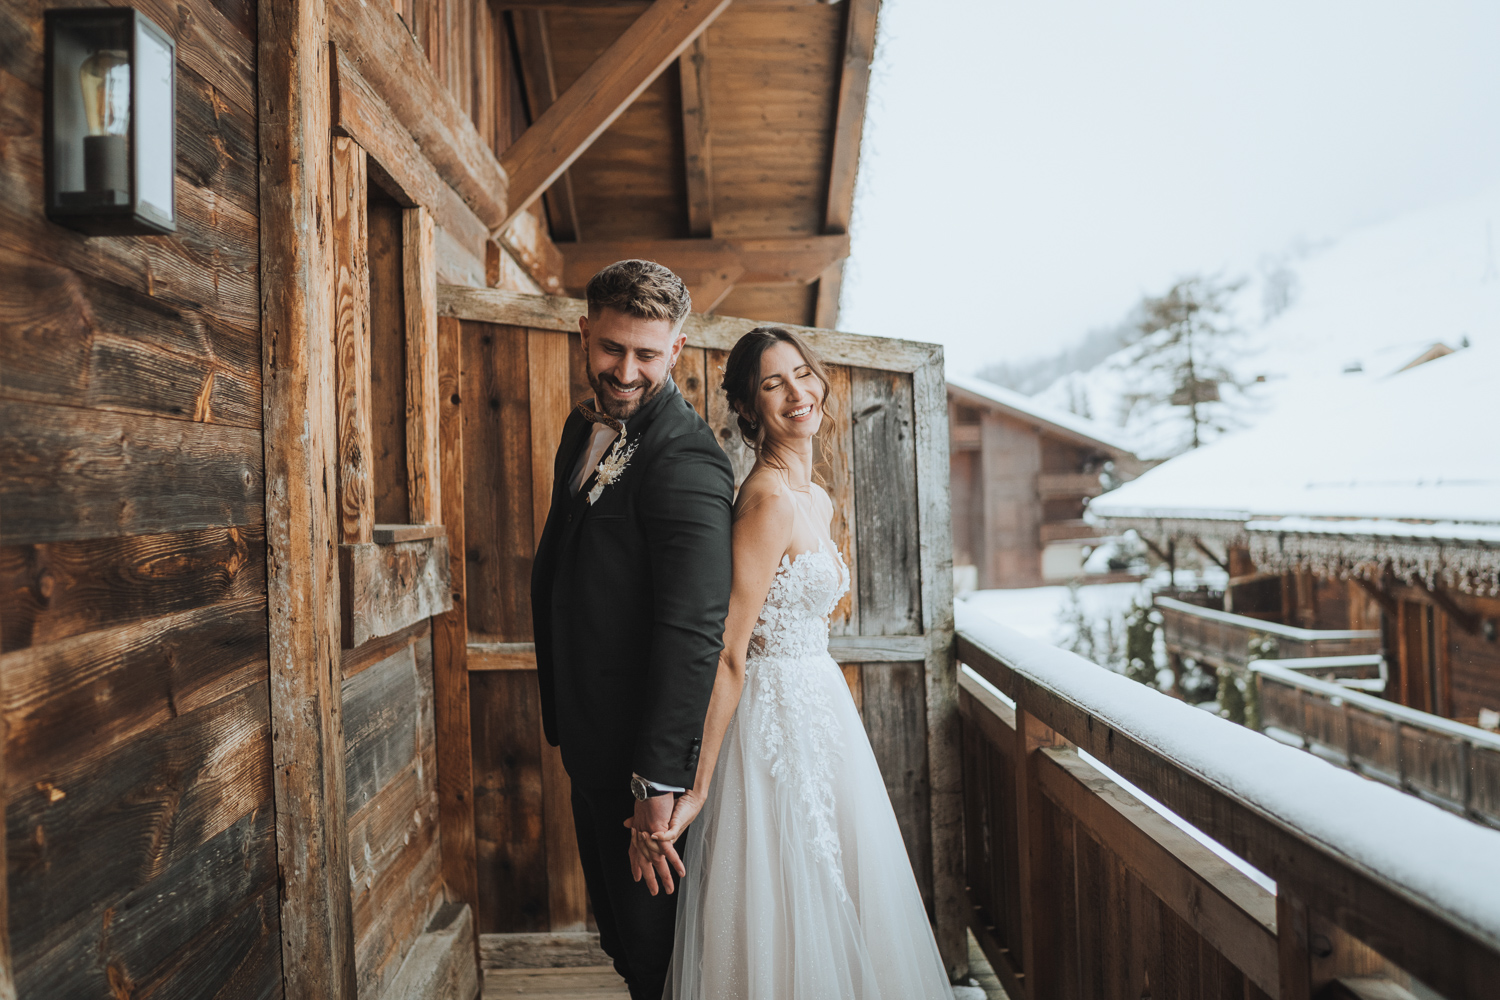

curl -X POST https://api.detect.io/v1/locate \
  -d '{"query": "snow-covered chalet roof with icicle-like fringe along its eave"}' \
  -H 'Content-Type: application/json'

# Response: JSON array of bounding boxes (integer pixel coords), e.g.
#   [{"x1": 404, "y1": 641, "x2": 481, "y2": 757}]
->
[{"x1": 1089, "y1": 346, "x2": 1500, "y2": 594}]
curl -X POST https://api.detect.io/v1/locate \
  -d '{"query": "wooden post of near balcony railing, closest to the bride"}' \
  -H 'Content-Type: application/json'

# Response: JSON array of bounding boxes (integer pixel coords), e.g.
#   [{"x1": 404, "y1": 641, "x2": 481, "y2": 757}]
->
[{"x1": 1016, "y1": 705, "x2": 1071, "y2": 1000}]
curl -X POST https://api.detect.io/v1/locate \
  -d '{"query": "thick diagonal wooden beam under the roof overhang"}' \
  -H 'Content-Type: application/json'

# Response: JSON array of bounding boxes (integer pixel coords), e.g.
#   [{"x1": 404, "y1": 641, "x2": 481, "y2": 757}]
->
[{"x1": 495, "y1": 0, "x2": 729, "y2": 229}]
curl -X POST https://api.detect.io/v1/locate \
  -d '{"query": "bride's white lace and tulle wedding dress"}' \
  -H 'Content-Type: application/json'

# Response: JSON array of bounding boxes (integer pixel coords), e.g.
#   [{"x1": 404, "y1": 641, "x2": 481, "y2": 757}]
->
[{"x1": 665, "y1": 495, "x2": 953, "y2": 1000}]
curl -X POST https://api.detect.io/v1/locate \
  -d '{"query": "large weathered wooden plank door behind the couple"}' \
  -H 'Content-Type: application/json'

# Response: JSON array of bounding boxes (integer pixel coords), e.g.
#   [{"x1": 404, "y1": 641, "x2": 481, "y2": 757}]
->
[{"x1": 440, "y1": 286, "x2": 965, "y2": 961}]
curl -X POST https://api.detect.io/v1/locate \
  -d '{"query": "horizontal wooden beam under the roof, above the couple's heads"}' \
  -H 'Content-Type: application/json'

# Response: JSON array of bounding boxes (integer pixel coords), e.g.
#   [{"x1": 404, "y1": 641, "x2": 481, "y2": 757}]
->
[{"x1": 558, "y1": 235, "x2": 849, "y2": 296}]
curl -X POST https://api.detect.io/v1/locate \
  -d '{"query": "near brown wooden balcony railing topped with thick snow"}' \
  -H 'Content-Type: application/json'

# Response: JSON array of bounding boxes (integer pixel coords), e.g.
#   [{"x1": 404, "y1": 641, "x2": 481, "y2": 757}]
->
[{"x1": 956, "y1": 604, "x2": 1500, "y2": 1000}]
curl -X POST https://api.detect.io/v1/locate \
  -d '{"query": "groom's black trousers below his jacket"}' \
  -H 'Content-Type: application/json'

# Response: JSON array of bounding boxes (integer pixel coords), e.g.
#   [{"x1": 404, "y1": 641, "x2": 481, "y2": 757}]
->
[{"x1": 573, "y1": 786, "x2": 683, "y2": 1000}]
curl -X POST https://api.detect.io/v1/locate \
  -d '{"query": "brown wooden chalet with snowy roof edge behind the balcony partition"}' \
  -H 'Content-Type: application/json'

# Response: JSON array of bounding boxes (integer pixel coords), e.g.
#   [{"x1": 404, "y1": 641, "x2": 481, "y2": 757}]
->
[{"x1": 948, "y1": 375, "x2": 1142, "y2": 589}]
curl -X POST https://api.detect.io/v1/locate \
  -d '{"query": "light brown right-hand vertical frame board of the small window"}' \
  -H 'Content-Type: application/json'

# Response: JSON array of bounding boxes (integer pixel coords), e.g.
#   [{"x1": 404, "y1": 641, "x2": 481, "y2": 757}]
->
[{"x1": 401, "y1": 207, "x2": 443, "y2": 525}]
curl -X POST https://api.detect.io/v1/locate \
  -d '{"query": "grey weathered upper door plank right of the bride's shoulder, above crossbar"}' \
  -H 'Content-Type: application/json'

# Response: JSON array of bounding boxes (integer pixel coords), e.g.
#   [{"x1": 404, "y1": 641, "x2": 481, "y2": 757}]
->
[{"x1": 849, "y1": 369, "x2": 923, "y2": 636}]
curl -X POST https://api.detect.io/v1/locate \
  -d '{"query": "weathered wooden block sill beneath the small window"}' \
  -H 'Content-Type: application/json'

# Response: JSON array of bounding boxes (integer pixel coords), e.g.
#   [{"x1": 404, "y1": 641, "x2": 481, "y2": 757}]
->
[{"x1": 339, "y1": 537, "x2": 453, "y2": 649}]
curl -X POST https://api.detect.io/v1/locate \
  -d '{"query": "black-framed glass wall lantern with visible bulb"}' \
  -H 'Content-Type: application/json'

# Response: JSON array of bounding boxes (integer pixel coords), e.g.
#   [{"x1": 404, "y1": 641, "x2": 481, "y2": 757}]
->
[{"x1": 42, "y1": 7, "x2": 177, "y2": 235}]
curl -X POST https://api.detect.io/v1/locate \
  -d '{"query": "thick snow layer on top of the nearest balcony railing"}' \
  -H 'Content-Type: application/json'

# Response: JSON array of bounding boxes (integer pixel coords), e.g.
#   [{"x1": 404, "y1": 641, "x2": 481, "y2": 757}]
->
[{"x1": 954, "y1": 603, "x2": 1500, "y2": 951}]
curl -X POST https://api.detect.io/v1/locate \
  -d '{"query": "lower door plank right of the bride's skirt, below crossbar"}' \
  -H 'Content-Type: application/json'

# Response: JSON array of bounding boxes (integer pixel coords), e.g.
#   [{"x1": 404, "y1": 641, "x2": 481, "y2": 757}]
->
[{"x1": 861, "y1": 663, "x2": 933, "y2": 910}]
